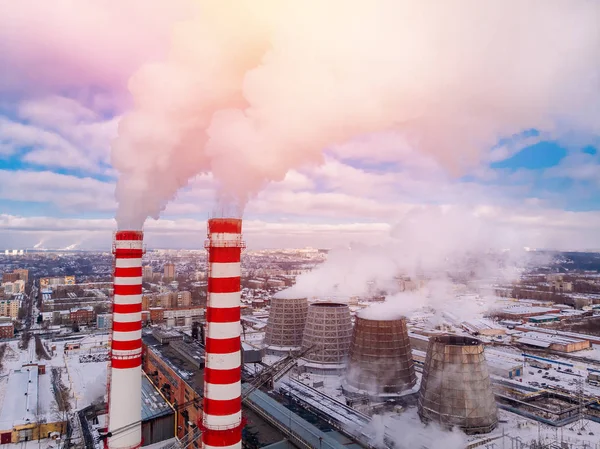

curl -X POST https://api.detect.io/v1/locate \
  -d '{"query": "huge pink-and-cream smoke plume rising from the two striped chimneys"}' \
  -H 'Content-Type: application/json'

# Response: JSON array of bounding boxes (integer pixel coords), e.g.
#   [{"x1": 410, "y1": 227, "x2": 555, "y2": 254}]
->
[{"x1": 112, "y1": 0, "x2": 600, "y2": 228}]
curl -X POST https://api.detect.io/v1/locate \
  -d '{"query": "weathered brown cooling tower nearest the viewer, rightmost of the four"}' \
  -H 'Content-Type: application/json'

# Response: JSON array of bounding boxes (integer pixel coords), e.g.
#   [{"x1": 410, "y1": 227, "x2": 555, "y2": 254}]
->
[{"x1": 419, "y1": 335, "x2": 498, "y2": 434}]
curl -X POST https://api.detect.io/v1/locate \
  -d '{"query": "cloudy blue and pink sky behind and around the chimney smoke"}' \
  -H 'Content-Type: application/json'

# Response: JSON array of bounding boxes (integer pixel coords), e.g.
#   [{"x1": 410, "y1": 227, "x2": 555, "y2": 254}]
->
[{"x1": 0, "y1": 1, "x2": 600, "y2": 250}]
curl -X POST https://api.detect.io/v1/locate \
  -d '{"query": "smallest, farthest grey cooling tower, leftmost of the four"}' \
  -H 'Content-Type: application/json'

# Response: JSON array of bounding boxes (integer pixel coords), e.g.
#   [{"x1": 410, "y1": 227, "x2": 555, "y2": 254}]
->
[{"x1": 265, "y1": 298, "x2": 308, "y2": 354}]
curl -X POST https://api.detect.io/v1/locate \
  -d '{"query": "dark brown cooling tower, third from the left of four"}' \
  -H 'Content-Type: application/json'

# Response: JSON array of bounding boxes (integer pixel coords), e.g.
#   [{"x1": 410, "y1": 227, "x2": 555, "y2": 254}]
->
[{"x1": 346, "y1": 313, "x2": 417, "y2": 395}]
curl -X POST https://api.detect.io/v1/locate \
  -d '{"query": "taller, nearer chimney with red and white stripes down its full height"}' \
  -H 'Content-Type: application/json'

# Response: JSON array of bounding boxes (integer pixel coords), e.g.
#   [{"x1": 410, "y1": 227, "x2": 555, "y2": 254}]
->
[{"x1": 202, "y1": 218, "x2": 244, "y2": 449}]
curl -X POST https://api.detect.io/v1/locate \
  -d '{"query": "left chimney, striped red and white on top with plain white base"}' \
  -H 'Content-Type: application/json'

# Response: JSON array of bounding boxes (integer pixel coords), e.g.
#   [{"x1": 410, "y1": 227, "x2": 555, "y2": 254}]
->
[{"x1": 108, "y1": 231, "x2": 144, "y2": 449}]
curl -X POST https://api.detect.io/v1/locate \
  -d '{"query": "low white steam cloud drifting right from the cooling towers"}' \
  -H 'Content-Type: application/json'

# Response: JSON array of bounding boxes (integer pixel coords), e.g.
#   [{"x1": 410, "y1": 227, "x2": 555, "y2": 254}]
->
[{"x1": 277, "y1": 207, "x2": 529, "y2": 302}]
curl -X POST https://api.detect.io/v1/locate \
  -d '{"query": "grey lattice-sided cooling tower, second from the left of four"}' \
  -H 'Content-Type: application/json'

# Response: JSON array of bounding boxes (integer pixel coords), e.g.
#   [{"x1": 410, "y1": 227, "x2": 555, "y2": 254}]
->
[{"x1": 302, "y1": 302, "x2": 352, "y2": 372}]
